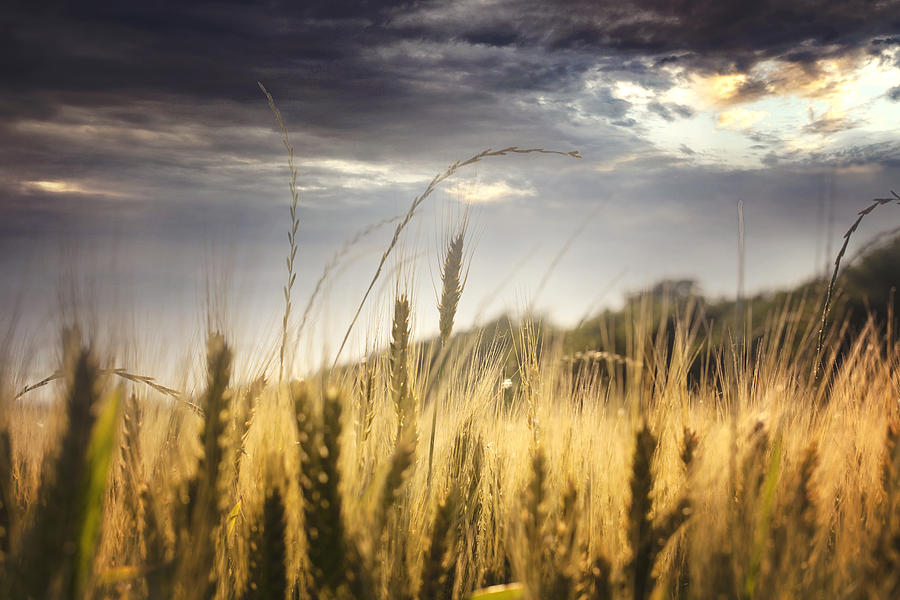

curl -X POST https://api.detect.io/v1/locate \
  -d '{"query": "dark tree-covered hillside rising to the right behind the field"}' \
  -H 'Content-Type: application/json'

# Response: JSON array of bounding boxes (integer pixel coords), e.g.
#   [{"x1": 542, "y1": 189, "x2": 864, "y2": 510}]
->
[{"x1": 352, "y1": 236, "x2": 900, "y2": 380}]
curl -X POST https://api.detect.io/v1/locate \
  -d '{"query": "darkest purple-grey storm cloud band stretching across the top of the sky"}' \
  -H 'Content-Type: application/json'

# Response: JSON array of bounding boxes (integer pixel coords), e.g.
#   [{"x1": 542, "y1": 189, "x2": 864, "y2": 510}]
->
[{"x1": 0, "y1": 0, "x2": 898, "y2": 169}]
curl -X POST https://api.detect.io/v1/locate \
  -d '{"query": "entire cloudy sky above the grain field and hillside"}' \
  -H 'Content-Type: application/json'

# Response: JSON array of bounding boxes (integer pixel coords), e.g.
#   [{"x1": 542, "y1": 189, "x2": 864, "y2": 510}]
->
[{"x1": 0, "y1": 0, "x2": 900, "y2": 366}]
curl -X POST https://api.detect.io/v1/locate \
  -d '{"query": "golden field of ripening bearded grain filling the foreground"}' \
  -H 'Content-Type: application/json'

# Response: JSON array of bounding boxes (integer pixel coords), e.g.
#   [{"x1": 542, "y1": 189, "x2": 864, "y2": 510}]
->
[{"x1": 0, "y1": 296, "x2": 900, "y2": 599}]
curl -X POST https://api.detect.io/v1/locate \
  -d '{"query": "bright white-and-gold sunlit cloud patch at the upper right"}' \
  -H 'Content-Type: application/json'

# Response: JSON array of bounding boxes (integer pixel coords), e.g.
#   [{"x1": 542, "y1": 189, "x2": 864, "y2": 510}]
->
[{"x1": 636, "y1": 50, "x2": 900, "y2": 167}]
